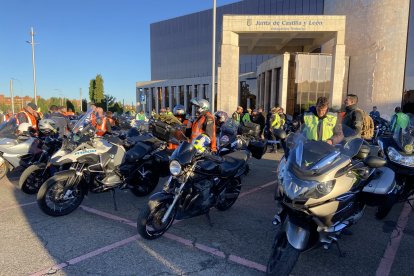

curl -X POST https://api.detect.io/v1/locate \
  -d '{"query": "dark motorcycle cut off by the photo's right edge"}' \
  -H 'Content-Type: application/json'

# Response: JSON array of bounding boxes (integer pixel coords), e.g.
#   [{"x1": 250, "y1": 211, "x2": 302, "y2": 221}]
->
[{"x1": 378, "y1": 114, "x2": 414, "y2": 212}]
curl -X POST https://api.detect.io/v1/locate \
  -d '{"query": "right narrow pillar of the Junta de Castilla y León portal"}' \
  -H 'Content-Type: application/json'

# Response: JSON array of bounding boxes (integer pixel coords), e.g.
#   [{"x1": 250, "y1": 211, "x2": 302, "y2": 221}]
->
[{"x1": 330, "y1": 39, "x2": 345, "y2": 109}]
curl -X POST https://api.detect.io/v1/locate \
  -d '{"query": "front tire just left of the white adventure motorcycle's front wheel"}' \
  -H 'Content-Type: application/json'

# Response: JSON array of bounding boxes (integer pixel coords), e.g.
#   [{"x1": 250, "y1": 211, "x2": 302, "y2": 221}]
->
[{"x1": 19, "y1": 164, "x2": 50, "y2": 195}]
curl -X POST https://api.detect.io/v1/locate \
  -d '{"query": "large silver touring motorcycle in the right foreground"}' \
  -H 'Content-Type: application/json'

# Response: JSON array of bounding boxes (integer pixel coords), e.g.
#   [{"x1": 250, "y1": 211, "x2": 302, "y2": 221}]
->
[{"x1": 267, "y1": 126, "x2": 396, "y2": 275}]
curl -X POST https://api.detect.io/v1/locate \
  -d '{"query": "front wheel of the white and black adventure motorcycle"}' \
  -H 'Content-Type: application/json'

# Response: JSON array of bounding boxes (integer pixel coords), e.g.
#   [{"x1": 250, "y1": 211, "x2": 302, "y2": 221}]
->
[{"x1": 37, "y1": 174, "x2": 85, "y2": 217}]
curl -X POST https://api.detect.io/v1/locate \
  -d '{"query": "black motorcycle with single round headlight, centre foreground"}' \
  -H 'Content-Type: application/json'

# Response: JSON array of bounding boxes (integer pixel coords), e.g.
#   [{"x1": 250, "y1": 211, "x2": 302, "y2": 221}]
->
[{"x1": 137, "y1": 142, "x2": 248, "y2": 240}]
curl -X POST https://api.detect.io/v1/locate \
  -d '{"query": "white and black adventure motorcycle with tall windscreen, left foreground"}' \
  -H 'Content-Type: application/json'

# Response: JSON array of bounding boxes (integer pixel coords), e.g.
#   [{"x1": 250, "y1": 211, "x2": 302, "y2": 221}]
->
[{"x1": 37, "y1": 111, "x2": 175, "y2": 216}]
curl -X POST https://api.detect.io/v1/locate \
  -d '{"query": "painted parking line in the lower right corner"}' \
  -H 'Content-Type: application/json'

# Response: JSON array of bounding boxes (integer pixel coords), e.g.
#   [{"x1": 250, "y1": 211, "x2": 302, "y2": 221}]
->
[{"x1": 376, "y1": 200, "x2": 414, "y2": 276}]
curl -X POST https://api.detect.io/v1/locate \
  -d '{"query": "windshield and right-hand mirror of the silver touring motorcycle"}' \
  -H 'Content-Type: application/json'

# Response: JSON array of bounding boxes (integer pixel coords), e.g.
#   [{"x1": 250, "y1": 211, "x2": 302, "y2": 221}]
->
[{"x1": 287, "y1": 125, "x2": 363, "y2": 174}]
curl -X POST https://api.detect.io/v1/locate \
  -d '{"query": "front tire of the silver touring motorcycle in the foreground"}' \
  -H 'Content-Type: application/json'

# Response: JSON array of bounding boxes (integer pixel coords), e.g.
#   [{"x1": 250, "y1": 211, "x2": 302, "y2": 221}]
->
[{"x1": 266, "y1": 230, "x2": 300, "y2": 276}]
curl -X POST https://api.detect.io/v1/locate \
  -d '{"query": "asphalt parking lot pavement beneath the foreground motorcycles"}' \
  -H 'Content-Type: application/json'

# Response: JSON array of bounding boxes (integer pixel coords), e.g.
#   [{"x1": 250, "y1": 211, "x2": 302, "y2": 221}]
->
[{"x1": 0, "y1": 153, "x2": 414, "y2": 275}]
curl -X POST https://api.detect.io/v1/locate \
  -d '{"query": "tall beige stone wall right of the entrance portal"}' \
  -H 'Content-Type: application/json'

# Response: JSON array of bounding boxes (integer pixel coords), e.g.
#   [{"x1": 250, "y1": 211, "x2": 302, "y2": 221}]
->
[{"x1": 325, "y1": 0, "x2": 409, "y2": 117}]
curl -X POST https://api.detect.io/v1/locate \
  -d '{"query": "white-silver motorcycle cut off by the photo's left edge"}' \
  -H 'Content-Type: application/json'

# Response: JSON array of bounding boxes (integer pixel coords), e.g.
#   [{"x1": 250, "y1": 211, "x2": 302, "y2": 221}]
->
[{"x1": 0, "y1": 118, "x2": 49, "y2": 179}]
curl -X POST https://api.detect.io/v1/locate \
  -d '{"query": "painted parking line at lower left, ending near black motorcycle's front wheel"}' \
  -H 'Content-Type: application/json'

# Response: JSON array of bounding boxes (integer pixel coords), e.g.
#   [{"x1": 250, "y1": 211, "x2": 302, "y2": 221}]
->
[{"x1": 30, "y1": 235, "x2": 140, "y2": 276}]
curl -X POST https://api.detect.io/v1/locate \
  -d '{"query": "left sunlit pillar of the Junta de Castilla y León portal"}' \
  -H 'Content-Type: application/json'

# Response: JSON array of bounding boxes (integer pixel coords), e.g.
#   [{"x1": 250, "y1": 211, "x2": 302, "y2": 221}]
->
[{"x1": 217, "y1": 30, "x2": 239, "y2": 114}]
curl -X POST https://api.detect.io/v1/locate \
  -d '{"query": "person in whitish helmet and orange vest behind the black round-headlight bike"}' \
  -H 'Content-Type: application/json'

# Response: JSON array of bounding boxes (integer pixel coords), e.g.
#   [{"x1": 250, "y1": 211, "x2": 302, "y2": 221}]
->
[{"x1": 191, "y1": 98, "x2": 217, "y2": 152}]
